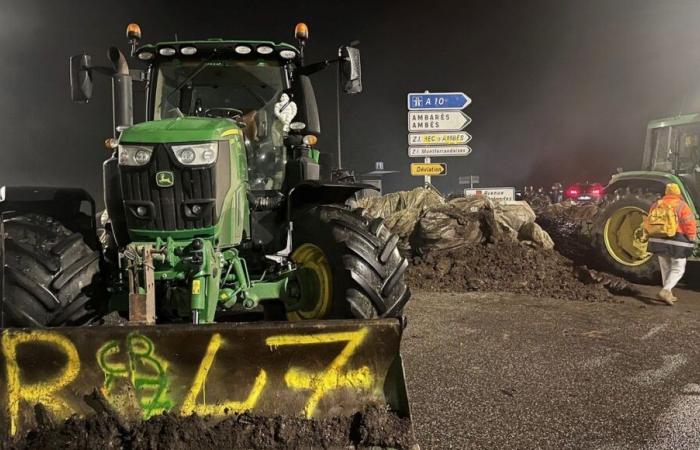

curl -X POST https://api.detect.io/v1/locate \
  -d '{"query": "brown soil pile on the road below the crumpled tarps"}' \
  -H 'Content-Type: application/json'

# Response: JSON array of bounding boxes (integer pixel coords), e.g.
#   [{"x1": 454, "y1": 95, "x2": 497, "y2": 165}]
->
[{"x1": 408, "y1": 242, "x2": 620, "y2": 302}]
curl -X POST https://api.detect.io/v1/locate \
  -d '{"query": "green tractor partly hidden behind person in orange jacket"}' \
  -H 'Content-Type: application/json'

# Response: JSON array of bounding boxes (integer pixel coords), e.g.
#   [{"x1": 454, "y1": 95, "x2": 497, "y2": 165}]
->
[{"x1": 594, "y1": 114, "x2": 700, "y2": 283}]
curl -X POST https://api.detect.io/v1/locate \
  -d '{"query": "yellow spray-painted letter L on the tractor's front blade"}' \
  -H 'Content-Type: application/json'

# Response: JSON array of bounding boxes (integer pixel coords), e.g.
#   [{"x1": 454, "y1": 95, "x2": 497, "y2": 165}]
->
[{"x1": 180, "y1": 333, "x2": 267, "y2": 415}]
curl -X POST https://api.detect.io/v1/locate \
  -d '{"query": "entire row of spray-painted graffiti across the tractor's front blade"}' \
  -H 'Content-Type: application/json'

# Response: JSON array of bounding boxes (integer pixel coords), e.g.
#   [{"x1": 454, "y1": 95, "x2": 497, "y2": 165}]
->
[{"x1": 1, "y1": 328, "x2": 376, "y2": 435}]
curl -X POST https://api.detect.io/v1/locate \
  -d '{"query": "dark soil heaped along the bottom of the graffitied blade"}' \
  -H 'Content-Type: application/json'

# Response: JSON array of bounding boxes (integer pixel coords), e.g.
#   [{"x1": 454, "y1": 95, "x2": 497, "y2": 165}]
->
[{"x1": 8, "y1": 407, "x2": 414, "y2": 450}]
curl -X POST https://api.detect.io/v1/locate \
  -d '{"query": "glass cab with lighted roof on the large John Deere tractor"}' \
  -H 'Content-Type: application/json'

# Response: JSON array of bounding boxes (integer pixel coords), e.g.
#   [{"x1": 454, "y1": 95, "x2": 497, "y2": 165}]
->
[{"x1": 141, "y1": 41, "x2": 308, "y2": 191}]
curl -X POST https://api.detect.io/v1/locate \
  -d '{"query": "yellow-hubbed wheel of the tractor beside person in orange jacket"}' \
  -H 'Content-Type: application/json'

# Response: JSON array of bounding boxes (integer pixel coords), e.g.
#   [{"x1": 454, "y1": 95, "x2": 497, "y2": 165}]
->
[{"x1": 594, "y1": 190, "x2": 660, "y2": 284}]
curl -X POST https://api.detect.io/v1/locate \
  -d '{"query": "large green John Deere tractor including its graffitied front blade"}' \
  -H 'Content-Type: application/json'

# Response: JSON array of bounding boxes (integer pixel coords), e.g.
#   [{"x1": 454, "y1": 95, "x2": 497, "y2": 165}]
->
[{"x1": 0, "y1": 24, "x2": 410, "y2": 434}]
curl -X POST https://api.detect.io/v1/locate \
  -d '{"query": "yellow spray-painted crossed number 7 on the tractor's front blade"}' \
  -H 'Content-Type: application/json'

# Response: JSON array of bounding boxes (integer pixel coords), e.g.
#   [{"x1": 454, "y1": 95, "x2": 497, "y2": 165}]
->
[{"x1": 265, "y1": 328, "x2": 373, "y2": 418}]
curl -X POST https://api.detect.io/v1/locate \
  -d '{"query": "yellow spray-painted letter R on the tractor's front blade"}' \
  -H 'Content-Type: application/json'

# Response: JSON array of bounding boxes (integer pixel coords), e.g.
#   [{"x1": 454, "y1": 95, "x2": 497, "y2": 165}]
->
[{"x1": 2, "y1": 331, "x2": 80, "y2": 436}]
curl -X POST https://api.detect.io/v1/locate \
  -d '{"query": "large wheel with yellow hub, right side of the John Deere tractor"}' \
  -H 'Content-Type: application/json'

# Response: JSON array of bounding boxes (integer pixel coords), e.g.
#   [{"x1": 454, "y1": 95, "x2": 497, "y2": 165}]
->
[{"x1": 287, "y1": 205, "x2": 411, "y2": 320}]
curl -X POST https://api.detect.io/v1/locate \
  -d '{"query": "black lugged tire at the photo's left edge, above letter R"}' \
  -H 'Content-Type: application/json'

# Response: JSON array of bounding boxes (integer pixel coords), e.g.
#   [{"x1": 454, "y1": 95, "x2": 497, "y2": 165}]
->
[{"x1": 3, "y1": 214, "x2": 99, "y2": 327}]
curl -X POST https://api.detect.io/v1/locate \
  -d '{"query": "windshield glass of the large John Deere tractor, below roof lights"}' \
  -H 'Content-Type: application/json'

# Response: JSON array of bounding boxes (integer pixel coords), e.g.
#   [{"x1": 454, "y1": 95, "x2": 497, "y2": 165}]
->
[{"x1": 153, "y1": 59, "x2": 287, "y2": 190}]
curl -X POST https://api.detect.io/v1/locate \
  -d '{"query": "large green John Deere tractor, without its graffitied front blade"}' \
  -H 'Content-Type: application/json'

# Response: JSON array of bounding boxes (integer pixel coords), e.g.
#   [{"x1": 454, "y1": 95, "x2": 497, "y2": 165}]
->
[{"x1": 3, "y1": 22, "x2": 410, "y2": 326}]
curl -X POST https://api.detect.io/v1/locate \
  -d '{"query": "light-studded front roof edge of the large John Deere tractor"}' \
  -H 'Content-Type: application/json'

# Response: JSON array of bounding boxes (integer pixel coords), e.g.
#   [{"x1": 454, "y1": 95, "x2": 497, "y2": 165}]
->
[{"x1": 136, "y1": 38, "x2": 300, "y2": 62}]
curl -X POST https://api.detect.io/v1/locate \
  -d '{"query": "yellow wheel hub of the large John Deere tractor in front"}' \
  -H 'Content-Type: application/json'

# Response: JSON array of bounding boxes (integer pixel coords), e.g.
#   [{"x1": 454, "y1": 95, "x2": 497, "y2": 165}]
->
[{"x1": 287, "y1": 244, "x2": 333, "y2": 320}]
